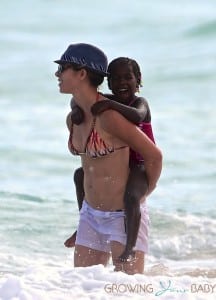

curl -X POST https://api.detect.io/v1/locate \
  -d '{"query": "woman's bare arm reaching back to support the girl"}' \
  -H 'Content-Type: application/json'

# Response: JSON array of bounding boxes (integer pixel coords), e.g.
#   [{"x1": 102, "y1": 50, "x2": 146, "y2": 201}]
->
[{"x1": 100, "y1": 110, "x2": 162, "y2": 194}]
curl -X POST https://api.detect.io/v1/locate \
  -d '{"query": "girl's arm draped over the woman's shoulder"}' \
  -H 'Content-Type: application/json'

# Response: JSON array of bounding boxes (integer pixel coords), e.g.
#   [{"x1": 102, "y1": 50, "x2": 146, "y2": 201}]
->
[{"x1": 91, "y1": 97, "x2": 150, "y2": 124}]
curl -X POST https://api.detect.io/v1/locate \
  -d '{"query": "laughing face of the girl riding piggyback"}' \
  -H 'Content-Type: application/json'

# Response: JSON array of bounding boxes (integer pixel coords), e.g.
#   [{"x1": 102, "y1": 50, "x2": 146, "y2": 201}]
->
[{"x1": 109, "y1": 64, "x2": 138, "y2": 104}]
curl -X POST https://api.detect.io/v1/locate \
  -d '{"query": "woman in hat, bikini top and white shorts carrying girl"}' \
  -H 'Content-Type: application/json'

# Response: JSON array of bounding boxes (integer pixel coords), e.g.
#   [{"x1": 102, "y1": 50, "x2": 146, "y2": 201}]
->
[{"x1": 55, "y1": 43, "x2": 162, "y2": 274}]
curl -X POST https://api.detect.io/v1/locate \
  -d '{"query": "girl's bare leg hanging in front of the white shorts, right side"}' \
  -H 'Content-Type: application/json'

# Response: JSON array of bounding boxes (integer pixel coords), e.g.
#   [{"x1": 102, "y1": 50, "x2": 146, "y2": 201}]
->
[{"x1": 119, "y1": 165, "x2": 148, "y2": 261}]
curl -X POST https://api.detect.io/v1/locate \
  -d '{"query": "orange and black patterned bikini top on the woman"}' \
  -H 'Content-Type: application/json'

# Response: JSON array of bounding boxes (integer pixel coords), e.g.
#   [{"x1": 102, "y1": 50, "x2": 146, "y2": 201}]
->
[{"x1": 68, "y1": 117, "x2": 128, "y2": 158}]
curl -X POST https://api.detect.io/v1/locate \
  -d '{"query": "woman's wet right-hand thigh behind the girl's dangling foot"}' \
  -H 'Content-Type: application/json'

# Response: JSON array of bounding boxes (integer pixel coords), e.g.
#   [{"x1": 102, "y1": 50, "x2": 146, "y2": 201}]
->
[{"x1": 111, "y1": 241, "x2": 145, "y2": 275}]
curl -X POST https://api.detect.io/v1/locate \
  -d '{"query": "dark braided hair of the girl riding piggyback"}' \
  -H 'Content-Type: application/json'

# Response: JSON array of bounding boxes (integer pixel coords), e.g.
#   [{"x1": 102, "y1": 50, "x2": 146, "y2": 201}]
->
[{"x1": 107, "y1": 57, "x2": 142, "y2": 88}]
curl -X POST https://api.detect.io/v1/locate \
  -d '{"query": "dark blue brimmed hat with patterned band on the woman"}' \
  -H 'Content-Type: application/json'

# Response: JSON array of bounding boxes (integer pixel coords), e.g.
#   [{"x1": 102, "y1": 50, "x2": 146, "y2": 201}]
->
[{"x1": 54, "y1": 43, "x2": 108, "y2": 76}]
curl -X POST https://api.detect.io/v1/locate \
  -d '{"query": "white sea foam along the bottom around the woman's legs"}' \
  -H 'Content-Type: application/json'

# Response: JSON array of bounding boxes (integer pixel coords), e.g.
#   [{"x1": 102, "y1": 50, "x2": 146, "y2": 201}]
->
[{"x1": 0, "y1": 265, "x2": 216, "y2": 300}]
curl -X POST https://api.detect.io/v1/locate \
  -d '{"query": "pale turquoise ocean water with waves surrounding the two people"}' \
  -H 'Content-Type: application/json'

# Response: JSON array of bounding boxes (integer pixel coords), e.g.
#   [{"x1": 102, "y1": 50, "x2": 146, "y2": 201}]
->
[{"x1": 0, "y1": 0, "x2": 216, "y2": 300}]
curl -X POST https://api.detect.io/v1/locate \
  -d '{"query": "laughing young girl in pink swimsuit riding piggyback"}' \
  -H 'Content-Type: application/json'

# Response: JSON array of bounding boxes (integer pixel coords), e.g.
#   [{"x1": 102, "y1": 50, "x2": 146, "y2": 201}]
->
[{"x1": 65, "y1": 57, "x2": 154, "y2": 261}]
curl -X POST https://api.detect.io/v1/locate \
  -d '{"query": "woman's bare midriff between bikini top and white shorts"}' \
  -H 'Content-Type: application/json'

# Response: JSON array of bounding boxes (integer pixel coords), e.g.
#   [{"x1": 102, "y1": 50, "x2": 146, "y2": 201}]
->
[{"x1": 82, "y1": 148, "x2": 129, "y2": 211}]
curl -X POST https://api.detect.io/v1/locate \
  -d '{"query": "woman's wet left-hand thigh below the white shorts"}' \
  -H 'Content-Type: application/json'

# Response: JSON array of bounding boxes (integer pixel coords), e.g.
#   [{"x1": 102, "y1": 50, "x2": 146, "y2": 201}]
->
[{"x1": 74, "y1": 245, "x2": 110, "y2": 267}]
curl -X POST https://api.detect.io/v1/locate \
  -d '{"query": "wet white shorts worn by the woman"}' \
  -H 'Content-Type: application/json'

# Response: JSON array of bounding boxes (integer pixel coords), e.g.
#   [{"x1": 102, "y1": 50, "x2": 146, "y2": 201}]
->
[{"x1": 76, "y1": 200, "x2": 149, "y2": 253}]
